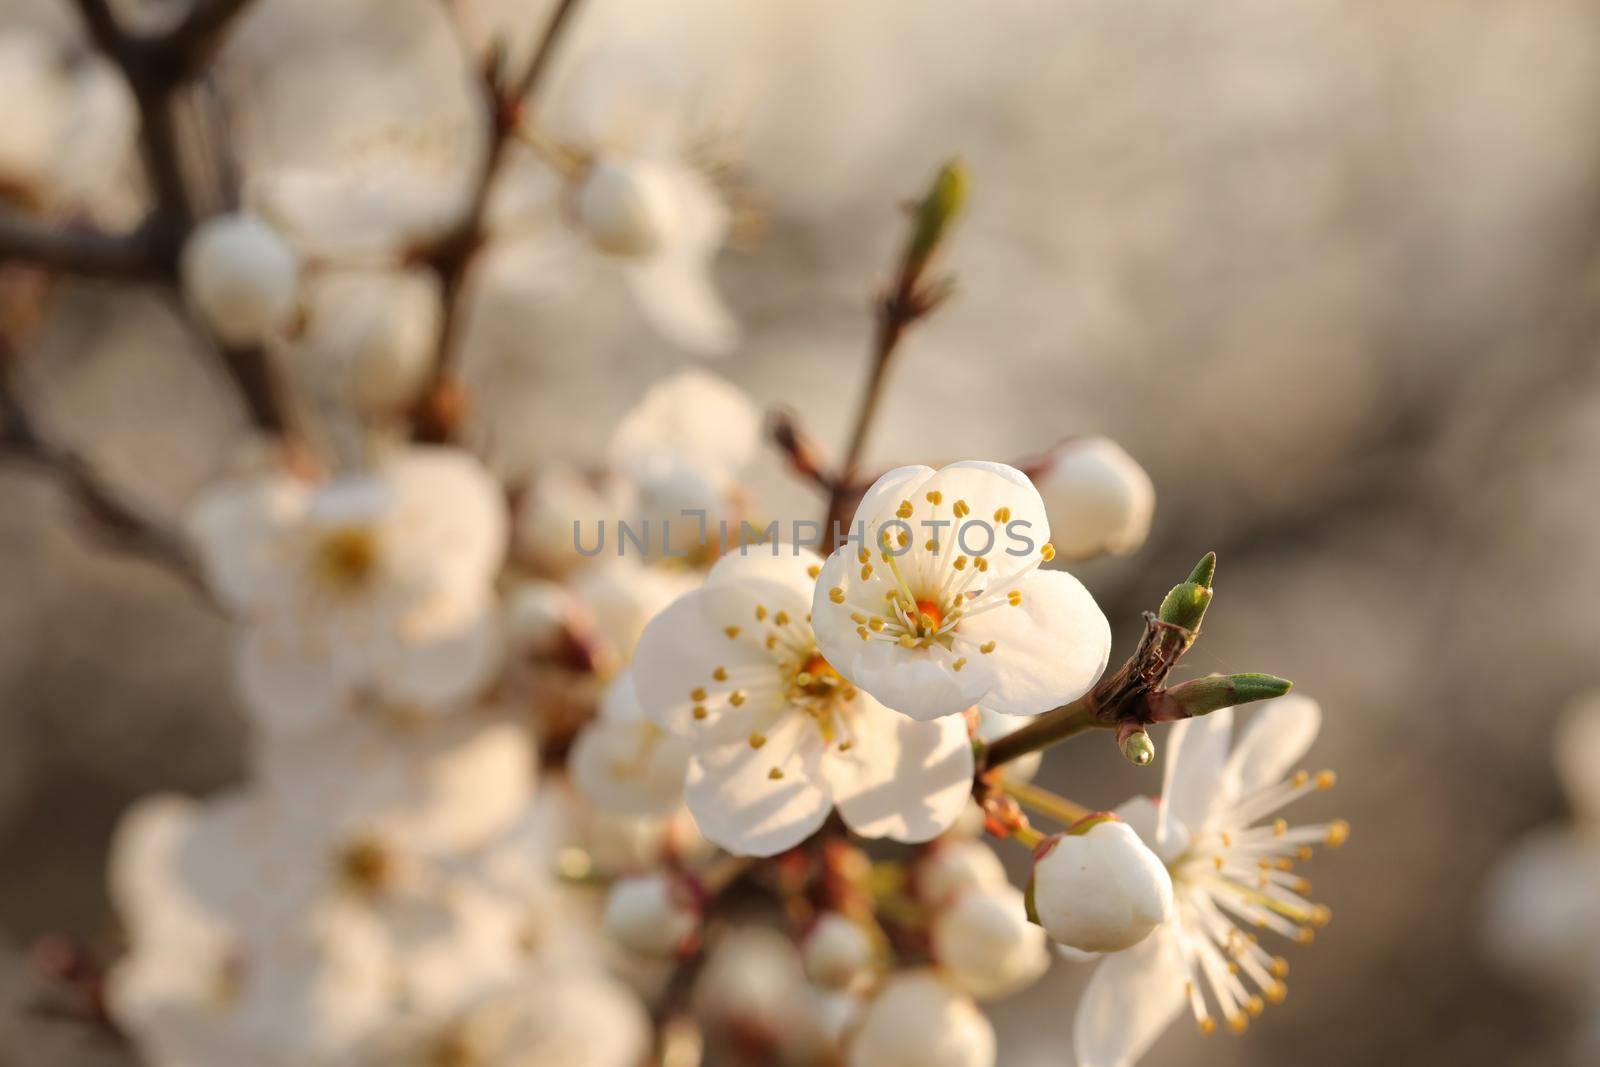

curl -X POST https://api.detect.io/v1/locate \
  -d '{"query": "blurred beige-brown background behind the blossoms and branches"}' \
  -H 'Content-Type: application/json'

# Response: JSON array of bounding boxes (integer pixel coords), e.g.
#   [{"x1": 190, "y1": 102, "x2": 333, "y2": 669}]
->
[{"x1": 0, "y1": 0, "x2": 1600, "y2": 1067}]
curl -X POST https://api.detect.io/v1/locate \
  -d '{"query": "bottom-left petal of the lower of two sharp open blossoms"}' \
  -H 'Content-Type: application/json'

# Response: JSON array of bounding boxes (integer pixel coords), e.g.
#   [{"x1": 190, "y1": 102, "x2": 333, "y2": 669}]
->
[{"x1": 685, "y1": 715, "x2": 834, "y2": 856}]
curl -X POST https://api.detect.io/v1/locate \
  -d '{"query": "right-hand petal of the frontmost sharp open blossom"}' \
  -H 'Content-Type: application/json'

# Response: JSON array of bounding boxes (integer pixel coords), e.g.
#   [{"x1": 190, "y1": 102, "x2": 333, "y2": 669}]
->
[{"x1": 957, "y1": 571, "x2": 1110, "y2": 715}]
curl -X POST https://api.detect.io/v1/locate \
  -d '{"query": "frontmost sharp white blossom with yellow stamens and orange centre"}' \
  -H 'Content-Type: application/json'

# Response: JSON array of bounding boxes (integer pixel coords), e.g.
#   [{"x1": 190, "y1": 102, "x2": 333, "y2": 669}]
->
[{"x1": 813, "y1": 461, "x2": 1110, "y2": 720}]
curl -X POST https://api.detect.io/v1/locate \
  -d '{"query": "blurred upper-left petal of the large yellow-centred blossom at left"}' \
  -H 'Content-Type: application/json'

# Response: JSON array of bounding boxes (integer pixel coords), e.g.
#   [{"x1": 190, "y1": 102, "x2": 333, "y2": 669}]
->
[{"x1": 189, "y1": 475, "x2": 307, "y2": 611}]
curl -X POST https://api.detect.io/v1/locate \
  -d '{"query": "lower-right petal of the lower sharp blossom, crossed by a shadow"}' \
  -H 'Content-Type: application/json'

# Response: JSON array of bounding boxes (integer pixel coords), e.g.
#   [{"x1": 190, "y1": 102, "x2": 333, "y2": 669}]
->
[{"x1": 826, "y1": 694, "x2": 973, "y2": 841}]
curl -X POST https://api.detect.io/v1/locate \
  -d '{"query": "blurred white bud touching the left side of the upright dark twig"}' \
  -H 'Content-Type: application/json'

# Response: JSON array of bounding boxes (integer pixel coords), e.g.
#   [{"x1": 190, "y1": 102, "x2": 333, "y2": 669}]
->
[{"x1": 304, "y1": 269, "x2": 443, "y2": 416}]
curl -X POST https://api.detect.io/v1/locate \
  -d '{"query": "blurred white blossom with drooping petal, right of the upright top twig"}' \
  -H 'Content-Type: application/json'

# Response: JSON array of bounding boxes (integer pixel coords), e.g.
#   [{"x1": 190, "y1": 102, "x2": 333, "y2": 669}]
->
[{"x1": 491, "y1": 58, "x2": 739, "y2": 355}]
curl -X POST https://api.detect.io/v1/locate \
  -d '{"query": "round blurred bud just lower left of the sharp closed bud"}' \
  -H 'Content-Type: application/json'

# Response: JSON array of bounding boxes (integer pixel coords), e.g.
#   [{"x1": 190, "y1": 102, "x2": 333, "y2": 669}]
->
[{"x1": 933, "y1": 886, "x2": 1050, "y2": 1000}]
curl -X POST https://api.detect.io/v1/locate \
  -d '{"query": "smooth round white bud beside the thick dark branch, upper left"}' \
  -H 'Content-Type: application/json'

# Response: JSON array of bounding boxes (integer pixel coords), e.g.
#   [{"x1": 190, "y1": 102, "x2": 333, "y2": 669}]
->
[{"x1": 181, "y1": 214, "x2": 299, "y2": 344}]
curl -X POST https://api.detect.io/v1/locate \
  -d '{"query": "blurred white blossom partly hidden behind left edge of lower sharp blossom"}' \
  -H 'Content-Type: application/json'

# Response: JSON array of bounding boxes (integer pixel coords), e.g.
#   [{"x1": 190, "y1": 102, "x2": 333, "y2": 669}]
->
[{"x1": 568, "y1": 675, "x2": 690, "y2": 816}]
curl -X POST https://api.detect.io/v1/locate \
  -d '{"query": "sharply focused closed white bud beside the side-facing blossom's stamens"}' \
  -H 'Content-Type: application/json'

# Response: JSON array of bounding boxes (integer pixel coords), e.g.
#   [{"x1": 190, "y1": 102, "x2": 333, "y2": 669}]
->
[{"x1": 1027, "y1": 816, "x2": 1173, "y2": 952}]
